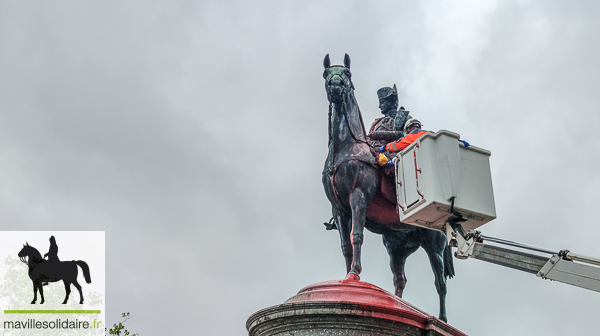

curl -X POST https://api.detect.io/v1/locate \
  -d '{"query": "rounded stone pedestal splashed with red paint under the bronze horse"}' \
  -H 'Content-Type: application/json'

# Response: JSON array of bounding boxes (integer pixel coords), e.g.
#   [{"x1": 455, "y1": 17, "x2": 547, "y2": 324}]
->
[{"x1": 246, "y1": 279, "x2": 466, "y2": 336}]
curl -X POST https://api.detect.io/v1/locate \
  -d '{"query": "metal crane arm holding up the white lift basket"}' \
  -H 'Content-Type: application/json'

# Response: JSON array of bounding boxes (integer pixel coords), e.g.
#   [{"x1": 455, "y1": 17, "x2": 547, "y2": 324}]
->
[{"x1": 444, "y1": 224, "x2": 600, "y2": 292}]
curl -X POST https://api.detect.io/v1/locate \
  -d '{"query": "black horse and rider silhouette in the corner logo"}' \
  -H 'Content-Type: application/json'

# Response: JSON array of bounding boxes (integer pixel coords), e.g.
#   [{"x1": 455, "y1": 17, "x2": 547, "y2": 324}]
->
[{"x1": 19, "y1": 236, "x2": 92, "y2": 304}]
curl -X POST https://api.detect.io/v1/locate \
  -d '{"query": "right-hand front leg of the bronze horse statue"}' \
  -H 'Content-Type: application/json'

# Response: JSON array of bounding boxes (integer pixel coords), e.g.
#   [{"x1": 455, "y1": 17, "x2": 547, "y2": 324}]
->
[{"x1": 348, "y1": 189, "x2": 367, "y2": 275}]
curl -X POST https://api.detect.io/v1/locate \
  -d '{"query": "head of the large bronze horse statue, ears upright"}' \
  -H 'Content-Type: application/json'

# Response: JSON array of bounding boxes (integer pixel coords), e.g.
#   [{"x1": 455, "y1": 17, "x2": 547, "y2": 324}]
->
[{"x1": 323, "y1": 54, "x2": 354, "y2": 103}]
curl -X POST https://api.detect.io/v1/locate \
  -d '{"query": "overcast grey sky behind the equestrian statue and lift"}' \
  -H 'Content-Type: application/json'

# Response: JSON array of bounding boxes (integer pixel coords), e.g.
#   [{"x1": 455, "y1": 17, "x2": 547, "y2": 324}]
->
[{"x1": 0, "y1": 0, "x2": 600, "y2": 336}]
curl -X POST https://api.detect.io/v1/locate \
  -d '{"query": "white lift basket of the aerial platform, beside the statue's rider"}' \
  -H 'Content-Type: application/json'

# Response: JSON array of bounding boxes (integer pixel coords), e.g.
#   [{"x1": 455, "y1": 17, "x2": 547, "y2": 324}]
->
[{"x1": 394, "y1": 130, "x2": 496, "y2": 230}]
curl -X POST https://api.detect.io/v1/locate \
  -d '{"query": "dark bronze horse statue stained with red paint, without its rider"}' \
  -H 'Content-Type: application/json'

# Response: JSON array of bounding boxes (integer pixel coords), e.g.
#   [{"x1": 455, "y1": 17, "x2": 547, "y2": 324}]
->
[{"x1": 322, "y1": 54, "x2": 454, "y2": 321}]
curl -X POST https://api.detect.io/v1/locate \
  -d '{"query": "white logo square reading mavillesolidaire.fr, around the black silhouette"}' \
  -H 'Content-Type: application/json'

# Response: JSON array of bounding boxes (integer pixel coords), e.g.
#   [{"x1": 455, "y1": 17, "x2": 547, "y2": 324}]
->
[{"x1": 0, "y1": 231, "x2": 106, "y2": 336}]
